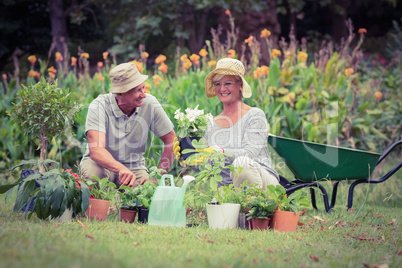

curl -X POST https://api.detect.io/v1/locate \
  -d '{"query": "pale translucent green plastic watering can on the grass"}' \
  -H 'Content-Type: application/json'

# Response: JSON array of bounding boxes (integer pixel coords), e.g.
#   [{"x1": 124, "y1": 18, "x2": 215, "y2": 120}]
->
[{"x1": 148, "y1": 174, "x2": 195, "y2": 227}]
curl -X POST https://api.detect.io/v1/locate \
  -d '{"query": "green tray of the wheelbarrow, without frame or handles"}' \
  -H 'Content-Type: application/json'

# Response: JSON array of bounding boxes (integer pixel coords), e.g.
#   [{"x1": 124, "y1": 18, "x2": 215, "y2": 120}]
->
[{"x1": 268, "y1": 135, "x2": 381, "y2": 182}]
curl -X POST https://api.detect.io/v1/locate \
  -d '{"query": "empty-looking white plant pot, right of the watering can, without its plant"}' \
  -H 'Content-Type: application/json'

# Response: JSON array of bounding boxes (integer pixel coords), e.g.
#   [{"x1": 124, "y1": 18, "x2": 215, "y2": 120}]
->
[{"x1": 207, "y1": 203, "x2": 240, "y2": 229}]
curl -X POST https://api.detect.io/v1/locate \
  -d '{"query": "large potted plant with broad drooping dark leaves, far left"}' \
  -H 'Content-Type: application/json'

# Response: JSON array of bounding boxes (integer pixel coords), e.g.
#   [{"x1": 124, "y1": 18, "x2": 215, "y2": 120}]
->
[{"x1": 0, "y1": 159, "x2": 90, "y2": 220}]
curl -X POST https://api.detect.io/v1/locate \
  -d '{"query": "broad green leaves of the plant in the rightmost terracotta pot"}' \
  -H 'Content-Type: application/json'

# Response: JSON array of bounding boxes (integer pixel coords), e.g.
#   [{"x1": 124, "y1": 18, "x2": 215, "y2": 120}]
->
[{"x1": 267, "y1": 185, "x2": 310, "y2": 213}]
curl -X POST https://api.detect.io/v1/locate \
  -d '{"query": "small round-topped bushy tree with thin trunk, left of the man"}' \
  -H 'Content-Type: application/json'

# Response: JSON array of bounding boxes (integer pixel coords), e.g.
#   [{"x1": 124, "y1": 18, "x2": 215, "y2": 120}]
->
[{"x1": 10, "y1": 77, "x2": 78, "y2": 172}]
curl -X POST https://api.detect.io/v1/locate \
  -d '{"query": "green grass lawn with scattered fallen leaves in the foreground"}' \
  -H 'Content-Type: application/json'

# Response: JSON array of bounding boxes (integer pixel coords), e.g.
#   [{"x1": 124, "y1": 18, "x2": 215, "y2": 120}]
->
[{"x1": 0, "y1": 160, "x2": 402, "y2": 267}]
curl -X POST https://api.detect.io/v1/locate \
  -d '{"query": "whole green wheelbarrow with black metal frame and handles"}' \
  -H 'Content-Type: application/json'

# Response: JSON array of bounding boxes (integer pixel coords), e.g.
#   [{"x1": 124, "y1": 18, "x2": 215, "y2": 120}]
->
[{"x1": 268, "y1": 135, "x2": 402, "y2": 212}]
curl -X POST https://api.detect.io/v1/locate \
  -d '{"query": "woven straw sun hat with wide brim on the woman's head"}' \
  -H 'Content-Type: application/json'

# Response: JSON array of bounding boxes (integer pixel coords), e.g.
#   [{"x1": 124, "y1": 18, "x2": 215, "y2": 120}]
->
[{"x1": 205, "y1": 58, "x2": 251, "y2": 98}]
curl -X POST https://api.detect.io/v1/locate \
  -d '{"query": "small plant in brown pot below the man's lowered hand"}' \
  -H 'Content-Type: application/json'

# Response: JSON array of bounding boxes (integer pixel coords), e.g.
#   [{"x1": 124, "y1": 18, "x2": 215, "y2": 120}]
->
[{"x1": 118, "y1": 186, "x2": 138, "y2": 223}]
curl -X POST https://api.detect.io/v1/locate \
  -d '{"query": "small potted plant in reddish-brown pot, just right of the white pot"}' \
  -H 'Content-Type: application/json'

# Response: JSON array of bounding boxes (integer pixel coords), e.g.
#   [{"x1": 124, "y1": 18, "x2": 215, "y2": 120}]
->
[{"x1": 246, "y1": 188, "x2": 278, "y2": 230}]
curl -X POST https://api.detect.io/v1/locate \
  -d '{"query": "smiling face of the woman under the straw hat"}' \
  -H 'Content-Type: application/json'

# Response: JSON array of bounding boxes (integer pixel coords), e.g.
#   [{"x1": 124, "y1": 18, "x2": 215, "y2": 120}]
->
[{"x1": 214, "y1": 75, "x2": 242, "y2": 103}]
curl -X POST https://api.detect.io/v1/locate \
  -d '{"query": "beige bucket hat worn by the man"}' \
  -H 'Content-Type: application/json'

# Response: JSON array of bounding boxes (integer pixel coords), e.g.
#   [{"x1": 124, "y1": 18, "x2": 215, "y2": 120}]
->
[{"x1": 109, "y1": 62, "x2": 148, "y2": 93}]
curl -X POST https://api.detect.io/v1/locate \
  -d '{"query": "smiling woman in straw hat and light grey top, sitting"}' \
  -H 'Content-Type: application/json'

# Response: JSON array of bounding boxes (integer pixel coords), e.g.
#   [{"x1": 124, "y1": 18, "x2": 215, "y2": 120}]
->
[{"x1": 175, "y1": 58, "x2": 279, "y2": 189}]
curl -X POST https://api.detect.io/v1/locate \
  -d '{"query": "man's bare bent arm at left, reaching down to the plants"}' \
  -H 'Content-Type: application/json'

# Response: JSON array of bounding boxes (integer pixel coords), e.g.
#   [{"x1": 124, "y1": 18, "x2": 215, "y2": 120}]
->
[{"x1": 87, "y1": 130, "x2": 136, "y2": 187}]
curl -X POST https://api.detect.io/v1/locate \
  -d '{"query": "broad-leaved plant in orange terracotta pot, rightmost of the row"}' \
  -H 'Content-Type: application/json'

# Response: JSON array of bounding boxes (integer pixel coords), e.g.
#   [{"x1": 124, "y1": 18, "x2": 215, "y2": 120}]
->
[{"x1": 267, "y1": 185, "x2": 310, "y2": 232}]
